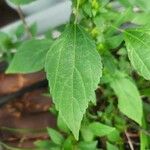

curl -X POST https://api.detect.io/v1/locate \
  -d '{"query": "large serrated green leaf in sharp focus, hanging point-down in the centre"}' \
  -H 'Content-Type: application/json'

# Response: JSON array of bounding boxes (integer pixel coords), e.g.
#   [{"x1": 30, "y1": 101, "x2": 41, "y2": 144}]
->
[{"x1": 45, "y1": 25, "x2": 102, "y2": 139}]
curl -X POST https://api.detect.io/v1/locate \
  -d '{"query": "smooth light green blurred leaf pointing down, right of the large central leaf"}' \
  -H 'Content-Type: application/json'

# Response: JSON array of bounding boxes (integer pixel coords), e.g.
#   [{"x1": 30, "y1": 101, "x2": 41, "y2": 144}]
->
[{"x1": 111, "y1": 78, "x2": 143, "y2": 125}]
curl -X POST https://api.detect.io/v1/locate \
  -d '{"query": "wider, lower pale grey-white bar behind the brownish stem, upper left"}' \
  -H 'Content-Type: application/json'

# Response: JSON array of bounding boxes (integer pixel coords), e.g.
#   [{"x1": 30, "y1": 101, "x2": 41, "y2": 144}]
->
[{"x1": 0, "y1": 1, "x2": 71, "y2": 34}]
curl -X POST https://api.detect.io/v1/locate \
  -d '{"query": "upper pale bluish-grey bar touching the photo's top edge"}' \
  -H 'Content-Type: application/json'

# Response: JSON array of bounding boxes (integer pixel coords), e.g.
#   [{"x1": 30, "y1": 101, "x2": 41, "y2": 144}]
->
[{"x1": 6, "y1": 0, "x2": 62, "y2": 15}]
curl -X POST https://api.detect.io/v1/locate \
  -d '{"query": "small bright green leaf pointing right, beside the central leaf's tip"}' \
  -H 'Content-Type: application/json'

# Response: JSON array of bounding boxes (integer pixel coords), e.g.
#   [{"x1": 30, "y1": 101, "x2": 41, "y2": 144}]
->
[{"x1": 89, "y1": 122, "x2": 115, "y2": 137}]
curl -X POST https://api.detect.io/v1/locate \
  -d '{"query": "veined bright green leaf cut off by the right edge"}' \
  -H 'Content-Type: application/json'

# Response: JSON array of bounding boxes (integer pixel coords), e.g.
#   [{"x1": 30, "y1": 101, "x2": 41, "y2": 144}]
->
[{"x1": 125, "y1": 27, "x2": 150, "y2": 80}]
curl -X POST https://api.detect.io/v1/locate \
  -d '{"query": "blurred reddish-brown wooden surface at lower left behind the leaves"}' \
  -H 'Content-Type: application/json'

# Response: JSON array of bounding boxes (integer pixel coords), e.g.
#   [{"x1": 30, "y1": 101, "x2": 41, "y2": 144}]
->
[{"x1": 0, "y1": 63, "x2": 56, "y2": 148}]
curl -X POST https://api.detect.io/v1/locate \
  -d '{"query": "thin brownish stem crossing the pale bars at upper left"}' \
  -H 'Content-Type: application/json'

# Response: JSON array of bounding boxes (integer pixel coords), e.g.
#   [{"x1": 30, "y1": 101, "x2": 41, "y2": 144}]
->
[{"x1": 17, "y1": 6, "x2": 32, "y2": 38}]
